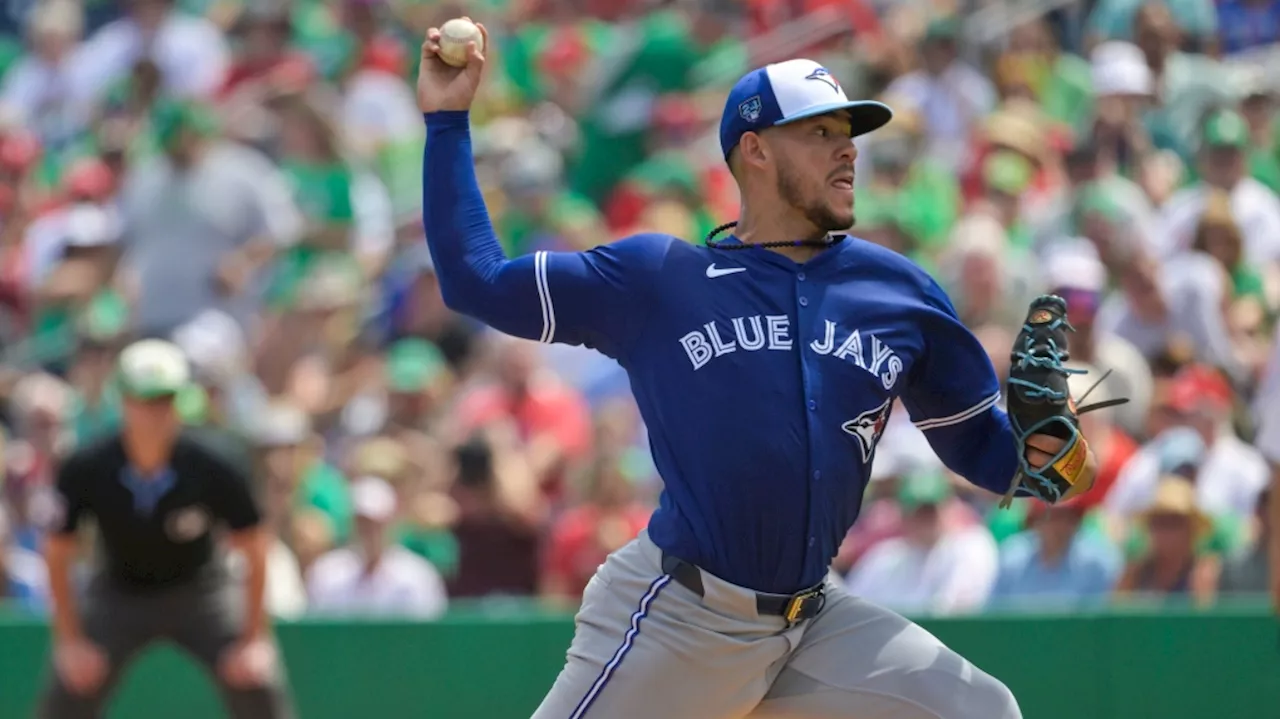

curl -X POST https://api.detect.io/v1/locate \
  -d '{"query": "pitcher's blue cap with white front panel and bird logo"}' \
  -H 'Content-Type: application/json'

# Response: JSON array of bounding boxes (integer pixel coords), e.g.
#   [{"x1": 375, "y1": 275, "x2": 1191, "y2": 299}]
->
[{"x1": 721, "y1": 58, "x2": 893, "y2": 157}]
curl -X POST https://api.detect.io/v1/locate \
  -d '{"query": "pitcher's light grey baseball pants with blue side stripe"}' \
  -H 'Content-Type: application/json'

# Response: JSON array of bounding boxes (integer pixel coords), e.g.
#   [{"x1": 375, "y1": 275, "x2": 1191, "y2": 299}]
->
[{"x1": 534, "y1": 533, "x2": 1021, "y2": 719}]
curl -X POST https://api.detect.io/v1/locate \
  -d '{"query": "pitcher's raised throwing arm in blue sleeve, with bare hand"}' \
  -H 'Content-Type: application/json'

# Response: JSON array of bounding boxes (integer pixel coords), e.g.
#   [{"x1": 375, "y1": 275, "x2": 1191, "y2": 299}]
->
[{"x1": 417, "y1": 23, "x2": 669, "y2": 357}]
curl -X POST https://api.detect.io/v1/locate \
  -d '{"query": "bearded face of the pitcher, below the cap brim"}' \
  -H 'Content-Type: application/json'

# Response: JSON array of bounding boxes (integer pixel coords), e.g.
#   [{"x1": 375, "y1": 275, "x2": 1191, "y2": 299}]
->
[{"x1": 774, "y1": 113, "x2": 858, "y2": 232}]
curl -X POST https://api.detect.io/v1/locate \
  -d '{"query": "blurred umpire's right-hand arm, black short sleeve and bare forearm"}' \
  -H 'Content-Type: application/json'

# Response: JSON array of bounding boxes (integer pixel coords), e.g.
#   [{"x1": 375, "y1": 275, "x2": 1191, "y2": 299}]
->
[{"x1": 204, "y1": 442, "x2": 271, "y2": 641}]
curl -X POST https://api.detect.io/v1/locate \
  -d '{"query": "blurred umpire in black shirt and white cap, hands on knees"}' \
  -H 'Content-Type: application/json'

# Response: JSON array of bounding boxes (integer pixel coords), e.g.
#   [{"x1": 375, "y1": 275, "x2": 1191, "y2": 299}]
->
[{"x1": 41, "y1": 339, "x2": 292, "y2": 719}]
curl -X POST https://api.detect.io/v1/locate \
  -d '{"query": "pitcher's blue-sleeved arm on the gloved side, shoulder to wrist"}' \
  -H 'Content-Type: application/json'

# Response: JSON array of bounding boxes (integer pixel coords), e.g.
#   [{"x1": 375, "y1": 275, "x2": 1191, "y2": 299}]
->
[{"x1": 902, "y1": 285, "x2": 1019, "y2": 494}]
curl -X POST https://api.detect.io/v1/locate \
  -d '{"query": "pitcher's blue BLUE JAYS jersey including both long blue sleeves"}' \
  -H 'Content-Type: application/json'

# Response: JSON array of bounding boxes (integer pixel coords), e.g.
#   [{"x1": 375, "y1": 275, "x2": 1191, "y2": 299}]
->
[{"x1": 424, "y1": 111, "x2": 1018, "y2": 594}]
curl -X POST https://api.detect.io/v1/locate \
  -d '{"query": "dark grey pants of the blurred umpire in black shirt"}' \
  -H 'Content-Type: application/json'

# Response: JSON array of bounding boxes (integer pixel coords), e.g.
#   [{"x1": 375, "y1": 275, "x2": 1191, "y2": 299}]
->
[{"x1": 37, "y1": 572, "x2": 293, "y2": 719}]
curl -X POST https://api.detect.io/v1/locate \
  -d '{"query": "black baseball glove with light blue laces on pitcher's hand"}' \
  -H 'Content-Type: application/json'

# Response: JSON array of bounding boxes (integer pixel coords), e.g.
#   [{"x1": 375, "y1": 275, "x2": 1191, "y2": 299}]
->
[{"x1": 1000, "y1": 294, "x2": 1129, "y2": 507}]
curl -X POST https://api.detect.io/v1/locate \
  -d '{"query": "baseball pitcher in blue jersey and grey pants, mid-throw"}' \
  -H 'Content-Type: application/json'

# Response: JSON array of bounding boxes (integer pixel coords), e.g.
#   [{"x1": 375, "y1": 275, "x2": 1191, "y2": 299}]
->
[{"x1": 417, "y1": 20, "x2": 1111, "y2": 719}]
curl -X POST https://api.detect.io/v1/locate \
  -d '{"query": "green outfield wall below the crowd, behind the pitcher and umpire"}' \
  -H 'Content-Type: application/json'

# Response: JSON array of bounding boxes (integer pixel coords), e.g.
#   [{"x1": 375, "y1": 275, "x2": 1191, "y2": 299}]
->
[{"x1": 0, "y1": 605, "x2": 1280, "y2": 719}]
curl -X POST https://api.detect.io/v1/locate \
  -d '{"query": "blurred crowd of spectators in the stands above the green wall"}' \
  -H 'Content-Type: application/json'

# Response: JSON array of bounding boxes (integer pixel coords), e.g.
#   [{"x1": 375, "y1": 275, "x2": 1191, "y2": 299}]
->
[{"x1": 0, "y1": 0, "x2": 1280, "y2": 618}]
